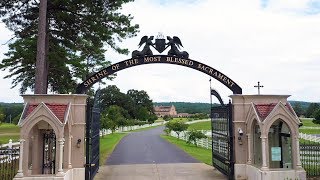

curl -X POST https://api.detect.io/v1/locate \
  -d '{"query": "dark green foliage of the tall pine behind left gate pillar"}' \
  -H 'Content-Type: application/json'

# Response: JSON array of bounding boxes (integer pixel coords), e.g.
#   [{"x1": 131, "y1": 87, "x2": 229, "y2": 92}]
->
[{"x1": 0, "y1": 0, "x2": 138, "y2": 93}]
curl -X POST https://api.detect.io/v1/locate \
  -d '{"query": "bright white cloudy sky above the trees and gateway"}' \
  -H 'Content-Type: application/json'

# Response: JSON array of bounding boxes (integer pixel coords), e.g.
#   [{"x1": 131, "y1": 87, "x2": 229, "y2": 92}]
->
[{"x1": 0, "y1": 0, "x2": 320, "y2": 102}]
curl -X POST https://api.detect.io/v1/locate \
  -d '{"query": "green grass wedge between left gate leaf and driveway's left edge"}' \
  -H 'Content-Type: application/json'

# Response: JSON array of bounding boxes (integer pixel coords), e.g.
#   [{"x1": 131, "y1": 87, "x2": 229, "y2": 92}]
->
[{"x1": 100, "y1": 133, "x2": 127, "y2": 165}]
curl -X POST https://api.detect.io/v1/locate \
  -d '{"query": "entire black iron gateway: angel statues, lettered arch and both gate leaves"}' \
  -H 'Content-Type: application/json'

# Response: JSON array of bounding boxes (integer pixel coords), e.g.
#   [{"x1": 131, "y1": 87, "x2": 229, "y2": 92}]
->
[{"x1": 80, "y1": 35, "x2": 242, "y2": 180}]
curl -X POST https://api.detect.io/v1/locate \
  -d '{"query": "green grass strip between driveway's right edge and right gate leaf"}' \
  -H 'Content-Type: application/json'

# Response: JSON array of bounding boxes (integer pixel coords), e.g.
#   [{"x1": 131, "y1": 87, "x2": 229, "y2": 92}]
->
[{"x1": 161, "y1": 135, "x2": 212, "y2": 165}]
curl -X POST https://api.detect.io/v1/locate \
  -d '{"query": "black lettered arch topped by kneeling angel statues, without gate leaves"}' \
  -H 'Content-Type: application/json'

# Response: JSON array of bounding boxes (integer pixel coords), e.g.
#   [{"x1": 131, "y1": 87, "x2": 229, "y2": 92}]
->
[{"x1": 76, "y1": 35, "x2": 242, "y2": 94}]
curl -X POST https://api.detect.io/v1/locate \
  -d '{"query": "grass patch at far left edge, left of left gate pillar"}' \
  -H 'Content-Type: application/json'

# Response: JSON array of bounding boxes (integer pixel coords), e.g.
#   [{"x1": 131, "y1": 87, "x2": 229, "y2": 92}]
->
[{"x1": 0, "y1": 123, "x2": 20, "y2": 144}]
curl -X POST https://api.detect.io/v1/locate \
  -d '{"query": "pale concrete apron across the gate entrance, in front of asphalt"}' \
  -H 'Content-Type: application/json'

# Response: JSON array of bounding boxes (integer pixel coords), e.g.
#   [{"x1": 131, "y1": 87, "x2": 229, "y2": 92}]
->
[{"x1": 94, "y1": 163, "x2": 227, "y2": 180}]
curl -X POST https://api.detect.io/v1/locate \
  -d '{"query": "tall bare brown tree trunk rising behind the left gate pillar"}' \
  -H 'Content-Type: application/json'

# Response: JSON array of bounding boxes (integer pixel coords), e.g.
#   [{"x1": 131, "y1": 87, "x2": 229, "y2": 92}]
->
[{"x1": 34, "y1": 0, "x2": 48, "y2": 94}]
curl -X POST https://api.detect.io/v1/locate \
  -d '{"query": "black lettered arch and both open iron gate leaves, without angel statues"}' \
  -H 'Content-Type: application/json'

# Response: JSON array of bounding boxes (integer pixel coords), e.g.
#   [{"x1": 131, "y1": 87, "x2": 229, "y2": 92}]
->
[{"x1": 76, "y1": 55, "x2": 242, "y2": 180}]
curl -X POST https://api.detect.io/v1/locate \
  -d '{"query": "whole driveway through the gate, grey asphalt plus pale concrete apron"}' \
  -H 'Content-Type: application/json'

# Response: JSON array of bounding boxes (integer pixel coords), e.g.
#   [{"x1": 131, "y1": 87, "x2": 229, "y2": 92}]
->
[{"x1": 94, "y1": 127, "x2": 227, "y2": 180}]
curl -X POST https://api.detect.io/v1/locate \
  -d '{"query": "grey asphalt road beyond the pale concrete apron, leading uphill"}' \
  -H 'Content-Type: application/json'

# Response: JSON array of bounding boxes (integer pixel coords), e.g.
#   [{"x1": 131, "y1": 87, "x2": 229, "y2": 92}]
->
[{"x1": 105, "y1": 126, "x2": 199, "y2": 165}]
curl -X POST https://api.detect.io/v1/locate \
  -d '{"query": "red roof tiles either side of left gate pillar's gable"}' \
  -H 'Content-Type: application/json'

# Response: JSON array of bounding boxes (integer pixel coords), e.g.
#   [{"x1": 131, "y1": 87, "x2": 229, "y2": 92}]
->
[{"x1": 24, "y1": 103, "x2": 68, "y2": 123}]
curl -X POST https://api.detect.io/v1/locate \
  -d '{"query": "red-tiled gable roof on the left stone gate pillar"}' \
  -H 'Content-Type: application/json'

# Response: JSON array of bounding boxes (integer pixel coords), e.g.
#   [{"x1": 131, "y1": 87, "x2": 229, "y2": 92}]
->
[{"x1": 21, "y1": 103, "x2": 70, "y2": 124}]
